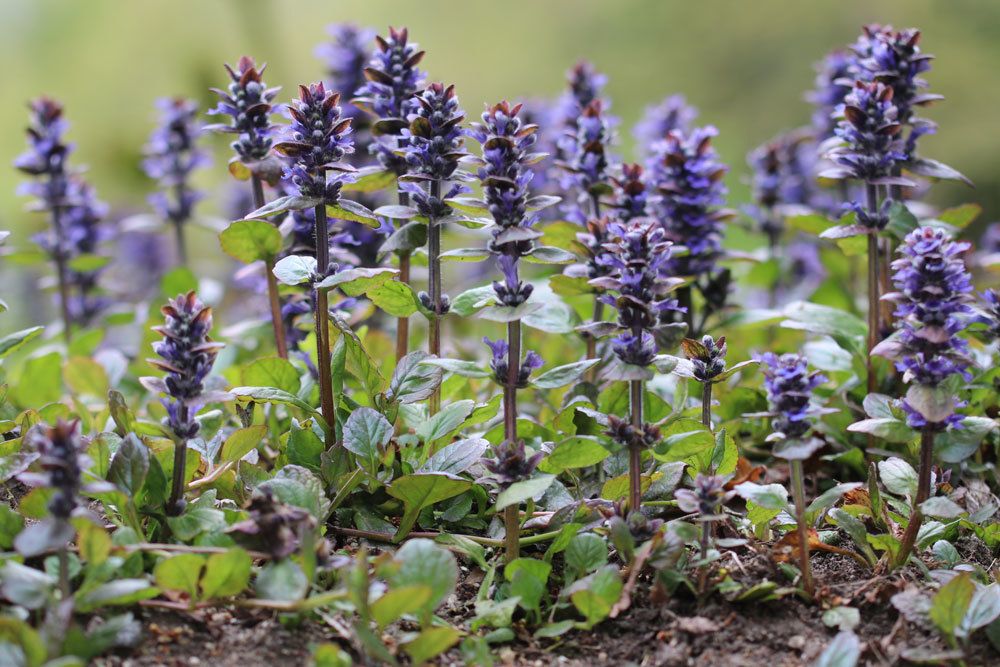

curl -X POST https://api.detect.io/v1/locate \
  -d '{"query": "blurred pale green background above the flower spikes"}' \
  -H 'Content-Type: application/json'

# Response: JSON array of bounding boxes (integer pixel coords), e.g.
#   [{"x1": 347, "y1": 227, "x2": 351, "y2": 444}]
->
[{"x1": 0, "y1": 0, "x2": 1000, "y2": 329}]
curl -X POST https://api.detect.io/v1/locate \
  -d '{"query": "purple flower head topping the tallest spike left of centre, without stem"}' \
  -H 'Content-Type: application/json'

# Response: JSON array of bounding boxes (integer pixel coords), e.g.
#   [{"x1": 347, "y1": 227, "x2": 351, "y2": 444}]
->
[{"x1": 353, "y1": 28, "x2": 425, "y2": 175}]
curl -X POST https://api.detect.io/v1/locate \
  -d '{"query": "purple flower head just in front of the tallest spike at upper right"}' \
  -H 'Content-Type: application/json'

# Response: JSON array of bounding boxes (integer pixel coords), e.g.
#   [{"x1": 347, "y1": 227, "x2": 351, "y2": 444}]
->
[{"x1": 821, "y1": 81, "x2": 906, "y2": 184}]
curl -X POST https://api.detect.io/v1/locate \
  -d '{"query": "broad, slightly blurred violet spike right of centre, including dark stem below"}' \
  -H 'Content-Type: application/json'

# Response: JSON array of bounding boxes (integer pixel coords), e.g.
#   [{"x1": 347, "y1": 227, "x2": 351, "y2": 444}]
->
[{"x1": 646, "y1": 126, "x2": 732, "y2": 337}]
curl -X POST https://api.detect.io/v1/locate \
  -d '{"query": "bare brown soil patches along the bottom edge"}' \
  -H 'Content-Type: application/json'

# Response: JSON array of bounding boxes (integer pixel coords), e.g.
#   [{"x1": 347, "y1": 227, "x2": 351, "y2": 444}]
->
[{"x1": 94, "y1": 538, "x2": 1000, "y2": 667}]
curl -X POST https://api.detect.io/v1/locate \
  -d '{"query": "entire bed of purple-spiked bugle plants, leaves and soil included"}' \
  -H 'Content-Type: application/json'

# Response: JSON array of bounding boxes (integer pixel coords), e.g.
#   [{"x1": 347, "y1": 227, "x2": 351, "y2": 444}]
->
[{"x1": 0, "y1": 18, "x2": 1000, "y2": 667}]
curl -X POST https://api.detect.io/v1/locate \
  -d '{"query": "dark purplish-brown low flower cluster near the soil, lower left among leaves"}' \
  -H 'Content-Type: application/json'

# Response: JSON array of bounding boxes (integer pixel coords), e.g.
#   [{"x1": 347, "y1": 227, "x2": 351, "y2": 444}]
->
[{"x1": 226, "y1": 488, "x2": 316, "y2": 560}]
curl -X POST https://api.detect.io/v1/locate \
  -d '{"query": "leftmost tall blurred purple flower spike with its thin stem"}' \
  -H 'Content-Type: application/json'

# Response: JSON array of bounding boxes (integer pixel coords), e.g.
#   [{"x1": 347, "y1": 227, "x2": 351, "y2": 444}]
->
[{"x1": 14, "y1": 97, "x2": 73, "y2": 343}]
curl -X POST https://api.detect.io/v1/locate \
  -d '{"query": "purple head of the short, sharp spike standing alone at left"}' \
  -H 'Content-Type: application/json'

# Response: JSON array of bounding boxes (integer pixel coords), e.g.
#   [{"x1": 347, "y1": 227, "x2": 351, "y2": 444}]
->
[{"x1": 149, "y1": 291, "x2": 223, "y2": 441}]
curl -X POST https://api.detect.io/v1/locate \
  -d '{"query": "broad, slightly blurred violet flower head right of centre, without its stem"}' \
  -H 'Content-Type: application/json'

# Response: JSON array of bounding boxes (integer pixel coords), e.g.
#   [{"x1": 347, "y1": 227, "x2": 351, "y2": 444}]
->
[{"x1": 647, "y1": 126, "x2": 728, "y2": 276}]
